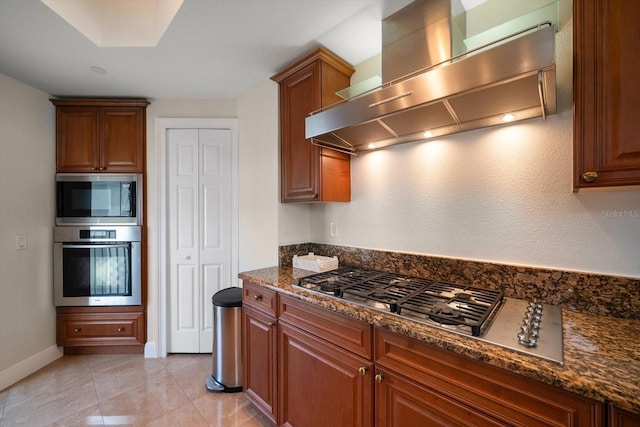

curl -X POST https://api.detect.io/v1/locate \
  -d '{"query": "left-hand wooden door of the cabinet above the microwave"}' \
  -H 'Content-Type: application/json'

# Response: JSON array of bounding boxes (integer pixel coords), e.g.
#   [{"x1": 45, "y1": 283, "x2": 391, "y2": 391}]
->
[{"x1": 56, "y1": 106, "x2": 99, "y2": 172}]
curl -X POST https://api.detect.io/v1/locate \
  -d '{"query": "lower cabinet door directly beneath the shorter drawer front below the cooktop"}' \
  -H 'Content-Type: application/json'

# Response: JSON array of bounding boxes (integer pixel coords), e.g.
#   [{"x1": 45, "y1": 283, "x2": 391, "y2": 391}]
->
[{"x1": 278, "y1": 321, "x2": 373, "y2": 427}]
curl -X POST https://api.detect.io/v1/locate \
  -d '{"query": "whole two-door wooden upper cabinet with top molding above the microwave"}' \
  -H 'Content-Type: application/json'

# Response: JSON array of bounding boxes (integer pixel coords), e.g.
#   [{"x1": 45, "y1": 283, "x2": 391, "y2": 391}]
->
[{"x1": 51, "y1": 99, "x2": 149, "y2": 173}]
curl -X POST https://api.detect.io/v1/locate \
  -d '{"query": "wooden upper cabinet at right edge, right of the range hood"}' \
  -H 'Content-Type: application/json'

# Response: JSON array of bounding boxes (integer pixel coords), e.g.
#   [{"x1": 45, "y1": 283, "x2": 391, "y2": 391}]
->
[{"x1": 573, "y1": 0, "x2": 640, "y2": 190}]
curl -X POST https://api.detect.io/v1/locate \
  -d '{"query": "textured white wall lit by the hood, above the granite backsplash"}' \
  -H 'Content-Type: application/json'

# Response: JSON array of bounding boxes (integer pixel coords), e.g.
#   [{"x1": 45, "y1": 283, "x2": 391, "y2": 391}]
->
[{"x1": 311, "y1": 1, "x2": 640, "y2": 277}]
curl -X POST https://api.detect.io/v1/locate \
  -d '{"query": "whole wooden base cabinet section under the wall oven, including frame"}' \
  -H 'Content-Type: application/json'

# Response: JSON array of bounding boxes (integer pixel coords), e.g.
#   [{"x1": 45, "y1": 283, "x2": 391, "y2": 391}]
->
[{"x1": 56, "y1": 307, "x2": 146, "y2": 354}]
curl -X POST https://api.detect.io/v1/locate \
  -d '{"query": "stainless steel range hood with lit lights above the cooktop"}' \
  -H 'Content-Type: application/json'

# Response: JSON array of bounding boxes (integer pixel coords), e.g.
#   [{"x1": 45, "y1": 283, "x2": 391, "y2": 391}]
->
[{"x1": 306, "y1": 0, "x2": 556, "y2": 154}]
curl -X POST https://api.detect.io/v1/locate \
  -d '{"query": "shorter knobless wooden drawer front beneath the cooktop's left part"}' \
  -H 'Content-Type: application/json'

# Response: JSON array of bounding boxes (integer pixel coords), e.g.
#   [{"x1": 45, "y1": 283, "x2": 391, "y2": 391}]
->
[{"x1": 279, "y1": 295, "x2": 373, "y2": 360}]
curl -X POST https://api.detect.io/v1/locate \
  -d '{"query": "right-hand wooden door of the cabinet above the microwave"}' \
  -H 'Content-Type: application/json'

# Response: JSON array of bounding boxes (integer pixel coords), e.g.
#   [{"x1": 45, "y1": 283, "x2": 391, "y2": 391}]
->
[{"x1": 100, "y1": 107, "x2": 145, "y2": 172}]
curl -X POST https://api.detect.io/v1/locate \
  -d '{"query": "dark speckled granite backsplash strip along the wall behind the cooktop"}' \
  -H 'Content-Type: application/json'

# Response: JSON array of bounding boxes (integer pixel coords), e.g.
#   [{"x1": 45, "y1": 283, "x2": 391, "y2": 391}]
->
[{"x1": 279, "y1": 243, "x2": 640, "y2": 320}]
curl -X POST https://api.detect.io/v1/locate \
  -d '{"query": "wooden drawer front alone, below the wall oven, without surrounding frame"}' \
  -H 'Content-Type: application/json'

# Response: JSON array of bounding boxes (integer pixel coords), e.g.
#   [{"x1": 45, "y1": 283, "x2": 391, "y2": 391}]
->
[{"x1": 57, "y1": 313, "x2": 144, "y2": 347}]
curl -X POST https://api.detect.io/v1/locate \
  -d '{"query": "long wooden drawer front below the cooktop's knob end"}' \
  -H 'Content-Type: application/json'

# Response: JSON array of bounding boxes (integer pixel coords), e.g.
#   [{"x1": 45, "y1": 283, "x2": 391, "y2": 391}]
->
[{"x1": 374, "y1": 328, "x2": 604, "y2": 426}]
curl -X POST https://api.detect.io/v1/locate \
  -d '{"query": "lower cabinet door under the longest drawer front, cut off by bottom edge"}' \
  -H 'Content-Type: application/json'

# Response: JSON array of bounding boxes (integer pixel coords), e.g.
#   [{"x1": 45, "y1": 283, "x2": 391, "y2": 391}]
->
[{"x1": 375, "y1": 369, "x2": 508, "y2": 427}]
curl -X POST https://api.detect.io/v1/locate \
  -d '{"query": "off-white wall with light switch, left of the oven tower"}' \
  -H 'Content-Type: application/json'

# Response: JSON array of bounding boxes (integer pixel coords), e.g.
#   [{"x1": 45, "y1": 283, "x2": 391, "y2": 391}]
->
[{"x1": 0, "y1": 74, "x2": 61, "y2": 390}]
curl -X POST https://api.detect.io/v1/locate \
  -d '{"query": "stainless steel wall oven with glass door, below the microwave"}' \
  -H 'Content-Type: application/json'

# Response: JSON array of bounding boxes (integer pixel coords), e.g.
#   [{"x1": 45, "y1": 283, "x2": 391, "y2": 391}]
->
[{"x1": 53, "y1": 225, "x2": 142, "y2": 306}]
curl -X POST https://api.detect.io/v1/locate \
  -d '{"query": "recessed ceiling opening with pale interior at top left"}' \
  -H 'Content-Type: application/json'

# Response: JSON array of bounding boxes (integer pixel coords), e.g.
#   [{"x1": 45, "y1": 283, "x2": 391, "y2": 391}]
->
[{"x1": 40, "y1": 0, "x2": 184, "y2": 47}]
